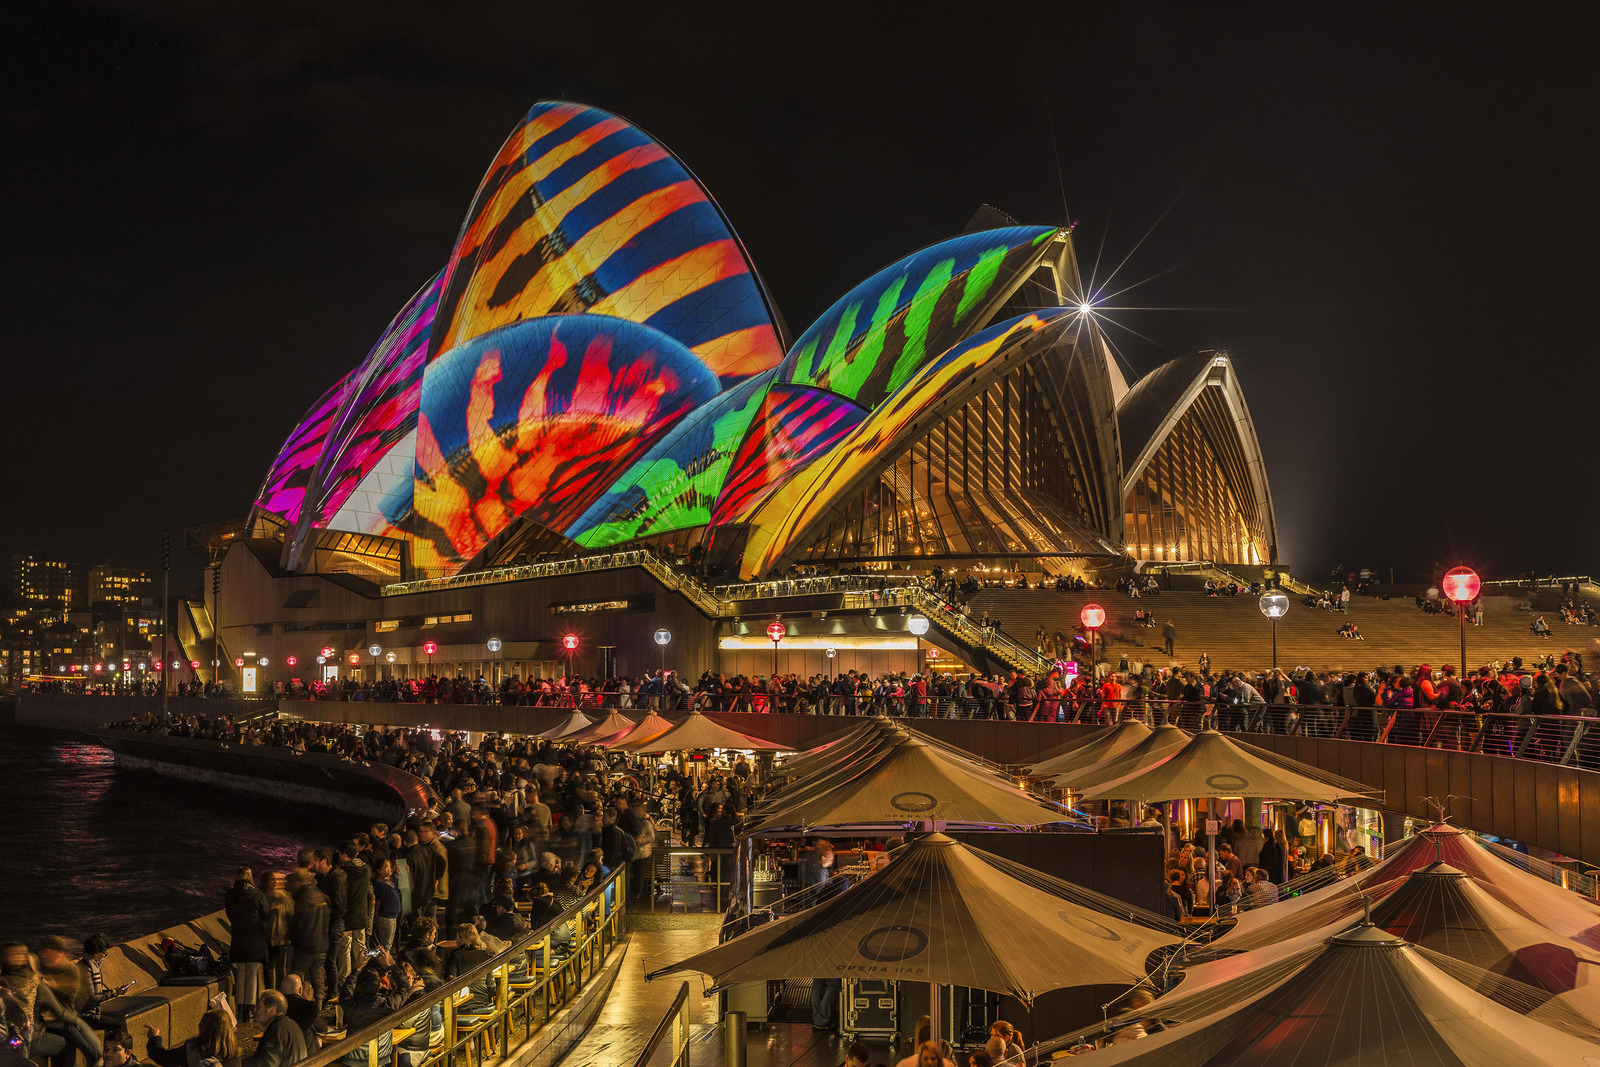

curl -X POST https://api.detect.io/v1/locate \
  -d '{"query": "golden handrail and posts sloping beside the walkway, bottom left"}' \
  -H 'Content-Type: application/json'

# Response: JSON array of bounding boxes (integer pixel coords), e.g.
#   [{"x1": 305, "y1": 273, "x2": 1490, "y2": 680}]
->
[{"x1": 298, "y1": 865, "x2": 627, "y2": 1067}]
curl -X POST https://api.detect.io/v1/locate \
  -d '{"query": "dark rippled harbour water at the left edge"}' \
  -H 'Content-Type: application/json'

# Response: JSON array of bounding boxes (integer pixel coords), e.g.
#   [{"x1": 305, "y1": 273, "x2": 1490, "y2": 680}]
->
[{"x1": 0, "y1": 725, "x2": 363, "y2": 941}]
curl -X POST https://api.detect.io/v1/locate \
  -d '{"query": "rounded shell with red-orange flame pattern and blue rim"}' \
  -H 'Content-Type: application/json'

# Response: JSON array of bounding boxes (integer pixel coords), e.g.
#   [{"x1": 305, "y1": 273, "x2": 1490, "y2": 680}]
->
[{"x1": 397, "y1": 315, "x2": 720, "y2": 573}]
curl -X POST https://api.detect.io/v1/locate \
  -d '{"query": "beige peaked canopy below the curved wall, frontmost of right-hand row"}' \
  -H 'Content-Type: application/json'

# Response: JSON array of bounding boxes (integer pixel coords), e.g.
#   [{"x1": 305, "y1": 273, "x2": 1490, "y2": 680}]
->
[{"x1": 1082, "y1": 729, "x2": 1382, "y2": 803}]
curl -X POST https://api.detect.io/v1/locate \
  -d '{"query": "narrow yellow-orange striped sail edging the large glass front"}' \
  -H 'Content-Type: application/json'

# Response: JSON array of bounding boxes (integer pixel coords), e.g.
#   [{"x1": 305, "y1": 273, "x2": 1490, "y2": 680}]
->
[{"x1": 742, "y1": 307, "x2": 1070, "y2": 574}]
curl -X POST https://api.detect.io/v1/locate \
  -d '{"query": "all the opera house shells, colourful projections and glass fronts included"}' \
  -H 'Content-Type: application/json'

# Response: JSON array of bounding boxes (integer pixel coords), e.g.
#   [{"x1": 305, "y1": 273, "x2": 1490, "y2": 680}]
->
[{"x1": 250, "y1": 102, "x2": 1275, "y2": 581}]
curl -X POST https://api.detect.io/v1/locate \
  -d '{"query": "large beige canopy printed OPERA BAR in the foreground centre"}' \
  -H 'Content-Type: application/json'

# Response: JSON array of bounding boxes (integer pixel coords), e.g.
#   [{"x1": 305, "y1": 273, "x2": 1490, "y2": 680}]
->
[{"x1": 648, "y1": 833, "x2": 1178, "y2": 1003}]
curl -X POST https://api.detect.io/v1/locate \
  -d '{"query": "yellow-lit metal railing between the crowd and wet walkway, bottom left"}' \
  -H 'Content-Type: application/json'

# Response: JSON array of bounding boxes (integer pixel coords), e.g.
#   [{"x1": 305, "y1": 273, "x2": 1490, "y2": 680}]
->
[{"x1": 301, "y1": 867, "x2": 627, "y2": 1067}]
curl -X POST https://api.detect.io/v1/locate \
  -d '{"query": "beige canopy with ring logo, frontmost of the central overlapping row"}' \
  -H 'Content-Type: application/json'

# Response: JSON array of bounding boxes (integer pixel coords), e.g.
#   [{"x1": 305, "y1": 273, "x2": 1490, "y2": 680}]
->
[{"x1": 745, "y1": 737, "x2": 1075, "y2": 829}]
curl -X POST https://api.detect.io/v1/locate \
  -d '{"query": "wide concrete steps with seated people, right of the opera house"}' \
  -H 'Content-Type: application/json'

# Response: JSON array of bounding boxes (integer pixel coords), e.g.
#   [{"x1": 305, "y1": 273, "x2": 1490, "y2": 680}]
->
[{"x1": 971, "y1": 576, "x2": 1600, "y2": 670}]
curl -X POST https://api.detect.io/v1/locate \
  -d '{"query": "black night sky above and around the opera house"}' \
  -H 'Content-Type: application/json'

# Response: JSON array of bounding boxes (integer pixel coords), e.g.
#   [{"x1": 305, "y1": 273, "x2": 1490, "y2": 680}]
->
[{"x1": 0, "y1": 0, "x2": 1600, "y2": 588}]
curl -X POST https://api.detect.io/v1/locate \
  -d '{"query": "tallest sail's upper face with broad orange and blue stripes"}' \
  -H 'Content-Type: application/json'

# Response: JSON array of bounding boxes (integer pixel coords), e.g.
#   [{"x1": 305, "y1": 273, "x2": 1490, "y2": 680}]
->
[{"x1": 429, "y1": 102, "x2": 782, "y2": 387}]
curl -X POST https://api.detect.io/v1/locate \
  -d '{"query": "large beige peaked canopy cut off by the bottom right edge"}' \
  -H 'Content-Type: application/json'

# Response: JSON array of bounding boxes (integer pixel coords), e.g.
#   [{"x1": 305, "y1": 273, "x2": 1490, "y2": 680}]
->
[{"x1": 1068, "y1": 925, "x2": 1600, "y2": 1067}]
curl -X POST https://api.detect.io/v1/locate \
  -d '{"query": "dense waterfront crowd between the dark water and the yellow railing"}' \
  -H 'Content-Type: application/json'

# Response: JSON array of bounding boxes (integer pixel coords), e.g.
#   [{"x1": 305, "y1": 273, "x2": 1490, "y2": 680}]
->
[{"x1": 0, "y1": 712, "x2": 780, "y2": 1067}]
